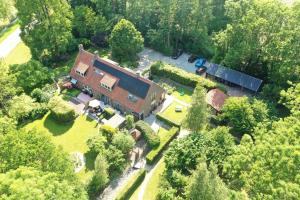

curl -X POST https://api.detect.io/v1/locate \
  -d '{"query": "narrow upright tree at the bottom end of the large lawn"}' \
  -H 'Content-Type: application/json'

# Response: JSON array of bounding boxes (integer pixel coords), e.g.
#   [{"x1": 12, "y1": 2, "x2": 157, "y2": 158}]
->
[{"x1": 88, "y1": 154, "x2": 109, "y2": 196}]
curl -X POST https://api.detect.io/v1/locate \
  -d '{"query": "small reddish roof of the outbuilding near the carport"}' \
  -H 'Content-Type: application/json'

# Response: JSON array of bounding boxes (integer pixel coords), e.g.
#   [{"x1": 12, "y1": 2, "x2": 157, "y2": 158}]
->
[{"x1": 206, "y1": 89, "x2": 228, "y2": 112}]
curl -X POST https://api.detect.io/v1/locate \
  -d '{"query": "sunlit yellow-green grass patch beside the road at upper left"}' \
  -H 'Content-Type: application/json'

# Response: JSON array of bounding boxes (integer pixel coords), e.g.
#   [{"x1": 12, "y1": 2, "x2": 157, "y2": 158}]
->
[{"x1": 4, "y1": 42, "x2": 31, "y2": 65}]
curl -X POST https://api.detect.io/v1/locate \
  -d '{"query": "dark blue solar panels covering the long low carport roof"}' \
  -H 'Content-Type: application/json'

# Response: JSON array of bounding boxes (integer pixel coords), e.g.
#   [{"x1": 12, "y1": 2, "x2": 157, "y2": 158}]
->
[{"x1": 206, "y1": 64, "x2": 262, "y2": 92}]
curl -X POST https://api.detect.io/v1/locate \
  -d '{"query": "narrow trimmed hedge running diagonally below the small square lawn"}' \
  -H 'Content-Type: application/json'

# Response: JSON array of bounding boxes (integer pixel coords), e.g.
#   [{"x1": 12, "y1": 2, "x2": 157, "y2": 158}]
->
[{"x1": 146, "y1": 127, "x2": 179, "y2": 165}]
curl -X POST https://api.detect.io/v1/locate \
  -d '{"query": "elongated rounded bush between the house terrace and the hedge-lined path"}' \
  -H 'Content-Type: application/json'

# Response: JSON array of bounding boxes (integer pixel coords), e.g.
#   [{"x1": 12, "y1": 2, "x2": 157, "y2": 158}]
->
[{"x1": 135, "y1": 120, "x2": 160, "y2": 148}]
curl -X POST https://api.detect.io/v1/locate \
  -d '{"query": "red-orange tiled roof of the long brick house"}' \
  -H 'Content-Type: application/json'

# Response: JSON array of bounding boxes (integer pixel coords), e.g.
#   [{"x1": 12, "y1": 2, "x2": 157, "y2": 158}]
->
[{"x1": 70, "y1": 50, "x2": 152, "y2": 113}]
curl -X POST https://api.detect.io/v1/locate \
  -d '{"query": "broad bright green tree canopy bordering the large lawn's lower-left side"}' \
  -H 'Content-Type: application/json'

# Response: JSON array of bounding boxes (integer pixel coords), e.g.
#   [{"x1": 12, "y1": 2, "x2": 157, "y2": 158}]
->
[{"x1": 0, "y1": 129, "x2": 74, "y2": 177}]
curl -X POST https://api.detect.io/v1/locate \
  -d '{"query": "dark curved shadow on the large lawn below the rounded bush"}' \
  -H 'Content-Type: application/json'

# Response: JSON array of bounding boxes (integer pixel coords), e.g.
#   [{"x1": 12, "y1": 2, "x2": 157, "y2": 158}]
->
[{"x1": 44, "y1": 115, "x2": 74, "y2": 136}]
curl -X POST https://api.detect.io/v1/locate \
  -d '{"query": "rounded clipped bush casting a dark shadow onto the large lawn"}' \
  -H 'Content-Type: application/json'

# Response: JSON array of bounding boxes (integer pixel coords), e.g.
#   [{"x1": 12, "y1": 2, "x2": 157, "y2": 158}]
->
[{"x1": 49, "y1": 96, "x2": 76, "y2": 123}]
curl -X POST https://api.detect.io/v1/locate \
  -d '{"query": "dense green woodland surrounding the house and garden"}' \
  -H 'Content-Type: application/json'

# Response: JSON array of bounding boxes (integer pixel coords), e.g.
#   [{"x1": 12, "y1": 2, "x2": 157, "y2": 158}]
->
[{"x1": 0, "y1": 0, "x2": 300, "y2": 200}]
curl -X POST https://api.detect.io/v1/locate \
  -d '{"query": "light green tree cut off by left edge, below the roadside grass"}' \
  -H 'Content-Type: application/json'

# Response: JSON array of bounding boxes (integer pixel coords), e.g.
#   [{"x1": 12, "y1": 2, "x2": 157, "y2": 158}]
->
[{"x1": 0, "y1": 61, "x2": 18, "y2": 109}]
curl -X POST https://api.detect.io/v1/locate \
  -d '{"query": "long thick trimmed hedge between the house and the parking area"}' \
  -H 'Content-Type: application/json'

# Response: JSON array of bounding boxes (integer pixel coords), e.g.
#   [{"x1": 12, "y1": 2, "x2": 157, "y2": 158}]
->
[{"x1": 150, "y1": 61, "x2": 218, "y2": 90}]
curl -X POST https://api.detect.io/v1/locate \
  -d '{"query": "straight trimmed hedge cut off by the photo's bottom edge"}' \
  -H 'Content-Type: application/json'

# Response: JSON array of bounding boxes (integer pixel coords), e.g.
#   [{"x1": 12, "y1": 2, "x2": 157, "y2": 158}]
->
[{"x1": 116, "y1": 169, "x2": 146, "y2": 200}]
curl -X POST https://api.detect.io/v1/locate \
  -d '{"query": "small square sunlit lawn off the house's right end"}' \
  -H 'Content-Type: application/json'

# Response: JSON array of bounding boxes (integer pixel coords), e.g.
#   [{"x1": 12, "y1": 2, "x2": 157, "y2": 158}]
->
[{"x1": 161, "y1": 101, "x2": 188, "y2": 124}]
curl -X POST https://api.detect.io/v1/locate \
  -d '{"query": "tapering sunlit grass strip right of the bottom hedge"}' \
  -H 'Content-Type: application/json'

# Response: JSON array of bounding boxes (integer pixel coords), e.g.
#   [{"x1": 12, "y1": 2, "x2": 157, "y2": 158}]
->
[{"x1": 143, "y1": 159, "x2": 165, "y2": 200}]
